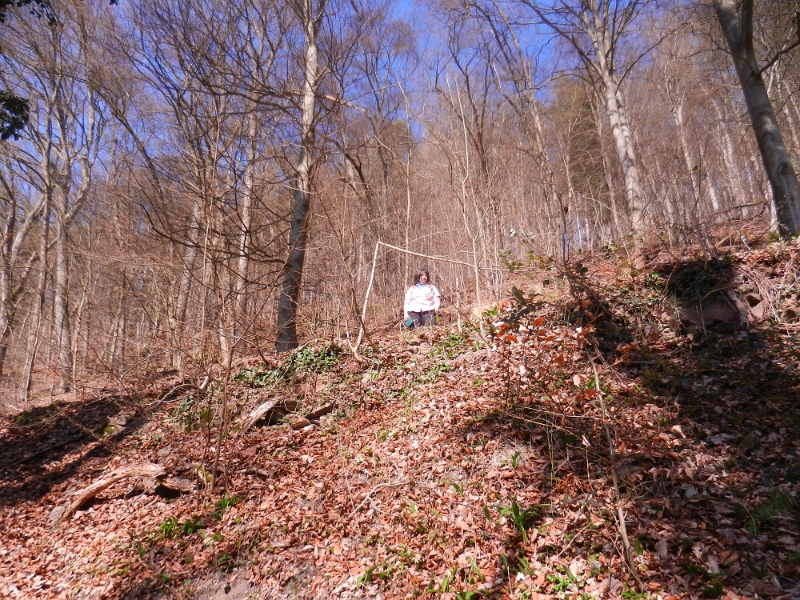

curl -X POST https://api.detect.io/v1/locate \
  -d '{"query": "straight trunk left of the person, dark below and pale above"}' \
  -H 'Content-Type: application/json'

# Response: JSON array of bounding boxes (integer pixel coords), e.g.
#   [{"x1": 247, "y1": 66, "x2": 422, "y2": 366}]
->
[{"x1": 275, "y1": 0, "x2": 325, "y2": 352}]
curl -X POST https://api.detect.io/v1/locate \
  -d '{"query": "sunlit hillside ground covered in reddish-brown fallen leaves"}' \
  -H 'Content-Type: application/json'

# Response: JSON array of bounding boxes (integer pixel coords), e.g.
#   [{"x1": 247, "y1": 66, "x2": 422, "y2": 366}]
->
[{"x1": 0, "y1": 240, "x2": 800, "y2": 600}]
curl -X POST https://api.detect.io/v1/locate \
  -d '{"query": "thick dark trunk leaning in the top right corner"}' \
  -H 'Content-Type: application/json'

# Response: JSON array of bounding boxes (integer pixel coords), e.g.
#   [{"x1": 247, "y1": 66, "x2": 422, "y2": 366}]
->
[{"x1": 714, "y1": 0, "x2": 800, "y2": 235}]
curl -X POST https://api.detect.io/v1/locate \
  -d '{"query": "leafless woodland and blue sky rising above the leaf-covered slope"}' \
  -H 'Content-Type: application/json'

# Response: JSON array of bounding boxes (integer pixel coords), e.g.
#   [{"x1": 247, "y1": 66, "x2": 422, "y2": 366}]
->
[{"x1": 0, "y1": 0, "x2": 800, "y2": 402}]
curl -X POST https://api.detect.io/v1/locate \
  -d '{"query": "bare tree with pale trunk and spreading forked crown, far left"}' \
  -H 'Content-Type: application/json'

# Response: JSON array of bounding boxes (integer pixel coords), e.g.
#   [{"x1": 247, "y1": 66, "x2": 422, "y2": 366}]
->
[{"x1": 0, "y1": 2, "x2": 105, "y2": 391}]
